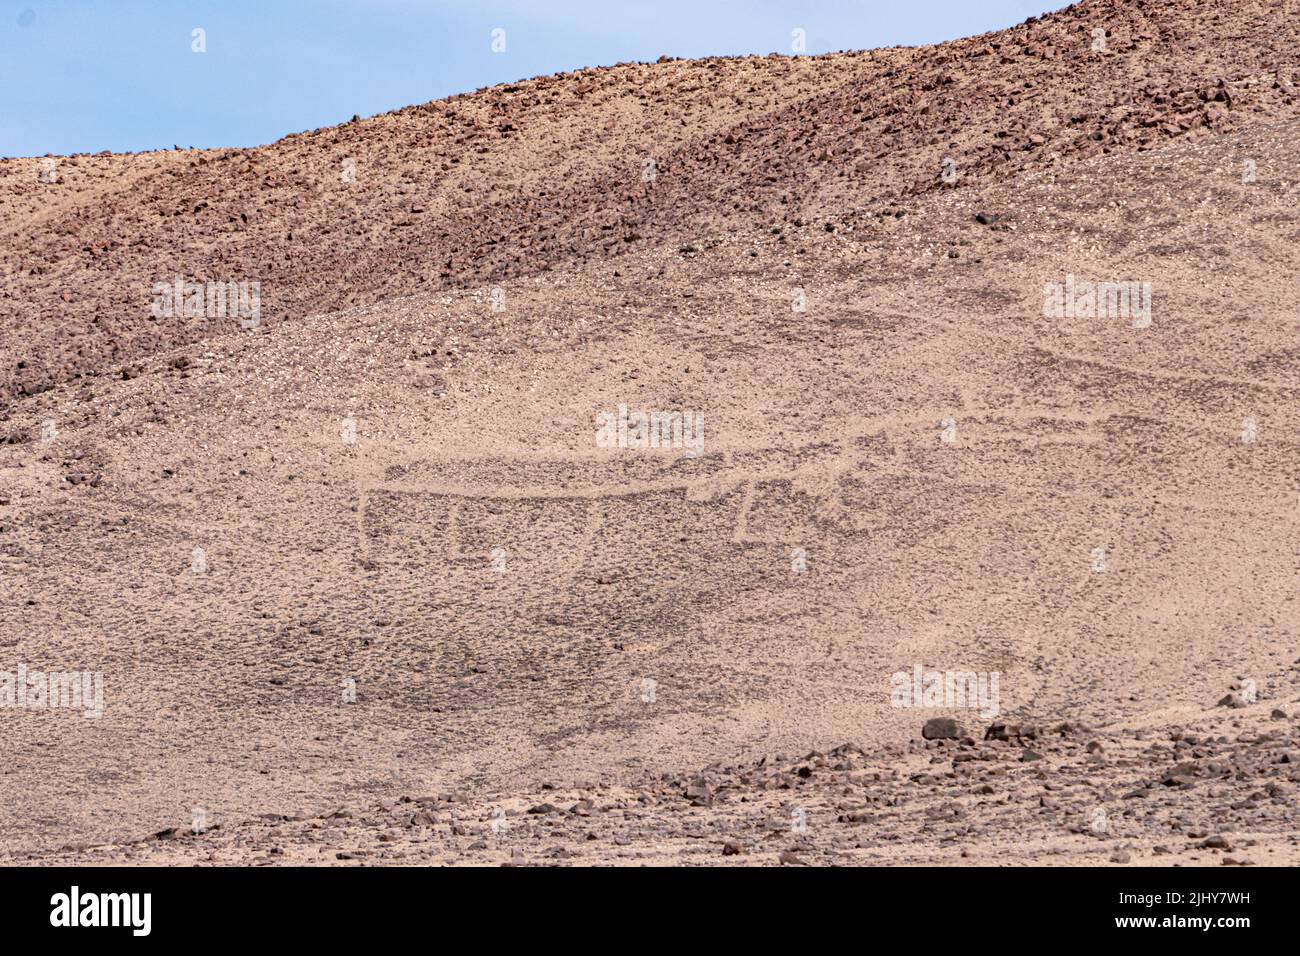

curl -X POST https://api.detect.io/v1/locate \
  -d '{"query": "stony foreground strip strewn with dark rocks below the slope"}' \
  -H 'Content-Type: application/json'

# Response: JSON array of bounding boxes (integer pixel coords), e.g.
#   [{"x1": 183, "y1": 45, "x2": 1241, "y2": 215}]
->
[{"x1": 12, "y1": 700, "x2": 1300, "y2": 866}]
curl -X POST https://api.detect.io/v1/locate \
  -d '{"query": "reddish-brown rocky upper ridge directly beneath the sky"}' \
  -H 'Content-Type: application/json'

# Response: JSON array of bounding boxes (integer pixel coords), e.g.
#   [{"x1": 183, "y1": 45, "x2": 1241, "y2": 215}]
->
[{"x1": 0, "y1": 0, "x2": 1297, "y2": 398}]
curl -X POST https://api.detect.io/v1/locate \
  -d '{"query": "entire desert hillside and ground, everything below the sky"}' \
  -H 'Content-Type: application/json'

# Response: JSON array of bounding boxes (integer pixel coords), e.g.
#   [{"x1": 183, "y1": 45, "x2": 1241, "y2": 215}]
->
[{"x1": 0, "y1": 3, "x2": 1300, "y2": 866}]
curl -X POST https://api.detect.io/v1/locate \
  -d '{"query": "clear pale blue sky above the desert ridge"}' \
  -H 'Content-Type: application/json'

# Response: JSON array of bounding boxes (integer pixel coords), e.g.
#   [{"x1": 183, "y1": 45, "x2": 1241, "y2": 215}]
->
[{"x1": 0, "y1": 0, "x2": 1066, "y2": 156}]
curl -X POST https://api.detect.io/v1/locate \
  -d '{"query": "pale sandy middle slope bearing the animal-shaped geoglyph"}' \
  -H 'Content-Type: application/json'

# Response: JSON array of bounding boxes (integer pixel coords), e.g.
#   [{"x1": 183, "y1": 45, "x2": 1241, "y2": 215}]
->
[{"x1": 4, "y1": 115, "x2": 1297, "y2": 852}]
